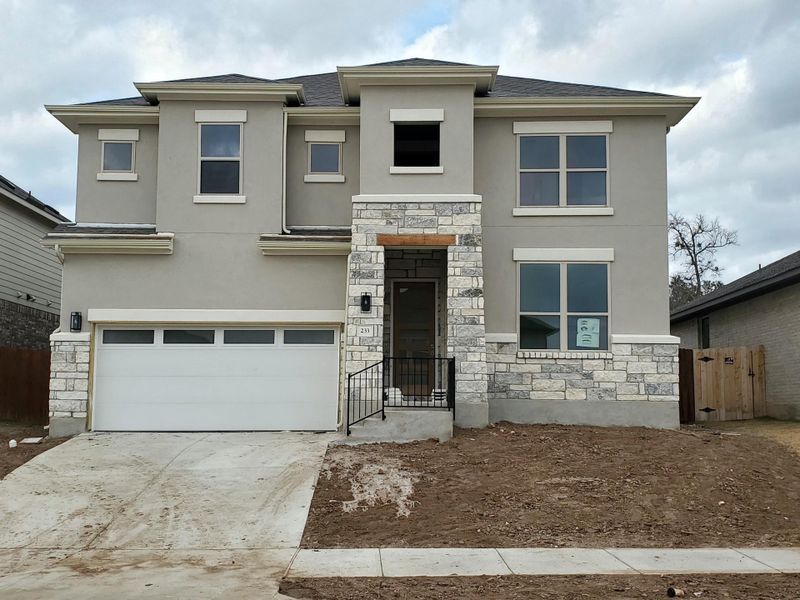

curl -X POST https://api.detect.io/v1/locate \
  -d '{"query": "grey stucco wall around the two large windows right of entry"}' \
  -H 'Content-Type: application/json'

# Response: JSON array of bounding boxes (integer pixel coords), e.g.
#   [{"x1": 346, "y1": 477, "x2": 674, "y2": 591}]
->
[{"x1": 475, "y1": 117, "x2": 669, "y2": 335}]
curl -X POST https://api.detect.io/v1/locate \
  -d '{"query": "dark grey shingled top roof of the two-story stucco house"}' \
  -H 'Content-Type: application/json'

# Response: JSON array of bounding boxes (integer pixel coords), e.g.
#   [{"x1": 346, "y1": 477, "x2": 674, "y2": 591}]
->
[{"x1": 72, "y1": 58, "x2": 670, "y2": 106}]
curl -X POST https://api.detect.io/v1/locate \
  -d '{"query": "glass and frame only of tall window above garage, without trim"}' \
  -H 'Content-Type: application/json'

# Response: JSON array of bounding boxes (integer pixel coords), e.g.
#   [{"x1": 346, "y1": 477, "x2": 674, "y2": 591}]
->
[{"x1": 200, "y1": 123, "x2": 242, "y2": 195}]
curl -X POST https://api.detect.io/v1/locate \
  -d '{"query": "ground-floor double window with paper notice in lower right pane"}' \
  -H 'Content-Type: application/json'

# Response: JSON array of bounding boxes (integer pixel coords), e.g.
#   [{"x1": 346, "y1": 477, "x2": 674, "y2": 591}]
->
[{"x1": 519, "y1": 263, "x2": 608, "y2": 350}]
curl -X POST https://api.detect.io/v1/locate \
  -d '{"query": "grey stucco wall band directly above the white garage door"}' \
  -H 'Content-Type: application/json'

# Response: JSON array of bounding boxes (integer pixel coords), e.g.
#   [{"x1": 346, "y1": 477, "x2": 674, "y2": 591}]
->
[{"x1": 61, "y1": 233, "x2": 347, "y2": 330}]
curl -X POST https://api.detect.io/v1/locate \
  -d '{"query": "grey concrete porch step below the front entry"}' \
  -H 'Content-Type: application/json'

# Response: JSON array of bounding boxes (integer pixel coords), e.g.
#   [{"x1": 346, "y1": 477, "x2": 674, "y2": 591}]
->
[{"x1": 349, "y1": 408, "x2": 453, "y2": 442}]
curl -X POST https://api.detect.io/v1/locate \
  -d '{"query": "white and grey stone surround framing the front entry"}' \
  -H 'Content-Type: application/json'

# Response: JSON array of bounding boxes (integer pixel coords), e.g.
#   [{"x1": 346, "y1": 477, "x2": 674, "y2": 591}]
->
[{"x1": 345, "y1": 196, "x2": 488, "y2": 427}]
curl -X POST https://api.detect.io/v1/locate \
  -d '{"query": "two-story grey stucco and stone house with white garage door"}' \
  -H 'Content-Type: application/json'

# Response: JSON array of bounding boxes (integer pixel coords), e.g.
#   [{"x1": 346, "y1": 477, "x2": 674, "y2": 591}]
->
[{"x1": 45, "y1": 59, "x2": 698, "y2": 437}]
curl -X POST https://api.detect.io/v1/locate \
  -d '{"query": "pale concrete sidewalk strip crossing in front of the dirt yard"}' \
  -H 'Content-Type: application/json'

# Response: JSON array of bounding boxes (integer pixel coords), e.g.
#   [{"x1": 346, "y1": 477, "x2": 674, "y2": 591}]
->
[{"x1": 288, "y1": 548, "x2": 800, "y2": 577}]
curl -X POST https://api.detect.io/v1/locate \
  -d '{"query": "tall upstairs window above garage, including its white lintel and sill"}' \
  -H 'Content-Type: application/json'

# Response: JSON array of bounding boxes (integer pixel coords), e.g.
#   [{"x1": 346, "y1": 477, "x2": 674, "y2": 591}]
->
[{"x1": 194, "y1": 110, "x2": 247, "y2": 204}]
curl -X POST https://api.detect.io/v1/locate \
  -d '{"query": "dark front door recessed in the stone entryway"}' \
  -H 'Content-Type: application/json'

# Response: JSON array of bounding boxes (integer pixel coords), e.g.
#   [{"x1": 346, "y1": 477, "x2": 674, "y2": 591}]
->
[{"x1": 392, "y1": 281, "x2": 436, "y2": 396}]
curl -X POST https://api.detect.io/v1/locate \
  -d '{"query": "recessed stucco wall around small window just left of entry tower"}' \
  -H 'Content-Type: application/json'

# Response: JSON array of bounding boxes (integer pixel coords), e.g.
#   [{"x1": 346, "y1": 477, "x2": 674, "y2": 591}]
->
[{"x1": 286, "y1": 125, "x2": 360, "y2": 227}]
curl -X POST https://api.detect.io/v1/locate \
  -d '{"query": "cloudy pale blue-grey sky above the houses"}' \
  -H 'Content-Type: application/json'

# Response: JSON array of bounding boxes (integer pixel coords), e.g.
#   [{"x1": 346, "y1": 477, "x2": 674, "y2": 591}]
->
[{"x1": 0, "y1": 0, "x2": 800, "y2": 281}]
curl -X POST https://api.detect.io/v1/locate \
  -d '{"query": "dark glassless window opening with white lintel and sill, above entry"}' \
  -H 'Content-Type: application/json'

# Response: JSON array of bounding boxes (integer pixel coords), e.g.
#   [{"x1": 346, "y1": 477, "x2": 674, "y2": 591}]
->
[{"x1": 389, "y1": 108, "x2": 444, "y2": 175}]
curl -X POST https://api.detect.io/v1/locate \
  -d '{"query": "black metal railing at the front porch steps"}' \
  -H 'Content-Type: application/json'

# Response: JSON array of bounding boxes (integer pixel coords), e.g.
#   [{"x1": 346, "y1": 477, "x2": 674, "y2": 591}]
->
[{"x1": 346, "y1": 356, "x2": 456, "y2": 435}]
